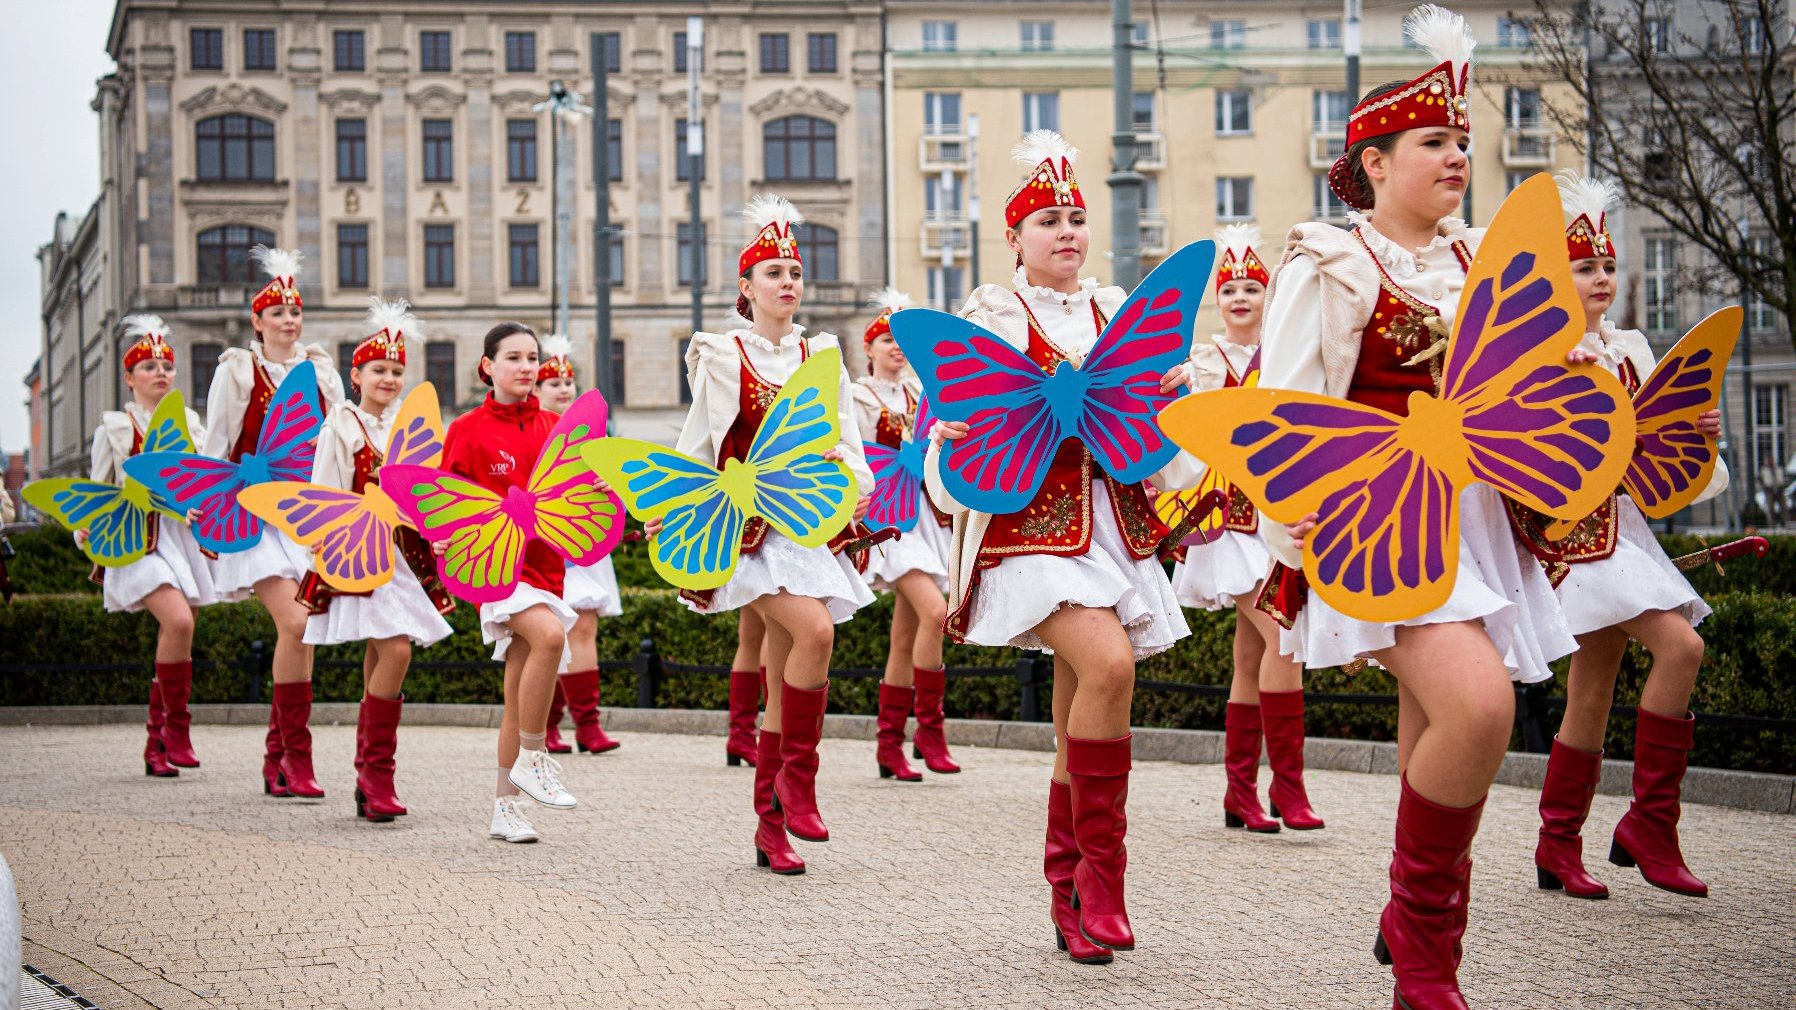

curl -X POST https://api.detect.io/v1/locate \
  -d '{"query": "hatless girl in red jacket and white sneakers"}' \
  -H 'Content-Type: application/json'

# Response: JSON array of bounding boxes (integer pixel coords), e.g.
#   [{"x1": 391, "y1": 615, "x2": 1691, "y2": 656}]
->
[{"x1": 435, "y1": 323, "x2": 575, "y2": 841}]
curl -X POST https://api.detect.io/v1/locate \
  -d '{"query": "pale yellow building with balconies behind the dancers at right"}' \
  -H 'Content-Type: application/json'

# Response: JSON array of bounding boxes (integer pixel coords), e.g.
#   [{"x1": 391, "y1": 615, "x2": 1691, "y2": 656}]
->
[{"x1": 885, "y1": 0, "x2": 1582, "y2": 336}]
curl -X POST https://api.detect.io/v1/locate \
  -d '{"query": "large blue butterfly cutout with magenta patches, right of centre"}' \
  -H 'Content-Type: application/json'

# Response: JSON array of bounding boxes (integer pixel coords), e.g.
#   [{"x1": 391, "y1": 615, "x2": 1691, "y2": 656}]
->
[{"x1": 891, "y1": 239, "x2": 1216, "y2": 514}]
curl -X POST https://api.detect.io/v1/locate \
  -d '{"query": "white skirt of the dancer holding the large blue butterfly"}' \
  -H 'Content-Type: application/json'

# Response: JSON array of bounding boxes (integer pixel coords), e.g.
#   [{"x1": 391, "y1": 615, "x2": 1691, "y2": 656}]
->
[{"x1": 966, "y1": 482, "x2": 1191, "y2": 660}]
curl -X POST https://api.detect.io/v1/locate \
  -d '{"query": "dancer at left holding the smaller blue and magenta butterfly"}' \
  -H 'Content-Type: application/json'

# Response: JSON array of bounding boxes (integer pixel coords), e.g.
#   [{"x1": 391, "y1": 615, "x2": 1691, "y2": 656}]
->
[{"x1": 199, "y1": 246, "x2": 343, "y2": 800}]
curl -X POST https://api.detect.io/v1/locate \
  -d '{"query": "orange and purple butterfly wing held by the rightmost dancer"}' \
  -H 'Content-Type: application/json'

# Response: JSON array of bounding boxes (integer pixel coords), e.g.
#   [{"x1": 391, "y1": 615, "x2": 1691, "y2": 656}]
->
[{"x1": 1622, "y1": 306, "x2": 1744, "y2": 519}]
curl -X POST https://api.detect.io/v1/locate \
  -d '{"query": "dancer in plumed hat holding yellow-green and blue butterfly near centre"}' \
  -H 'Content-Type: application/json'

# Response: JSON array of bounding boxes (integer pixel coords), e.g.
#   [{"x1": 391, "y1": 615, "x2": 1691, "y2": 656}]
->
[{"x1": 668, "y1": 196, "x2": 873, "y2": 873}]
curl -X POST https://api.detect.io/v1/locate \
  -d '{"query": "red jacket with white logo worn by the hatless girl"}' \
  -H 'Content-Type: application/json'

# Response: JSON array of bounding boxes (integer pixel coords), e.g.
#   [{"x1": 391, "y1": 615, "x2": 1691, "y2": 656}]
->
[{"x1": 444, "y1": 394, "x2": 566, "y2": 597}]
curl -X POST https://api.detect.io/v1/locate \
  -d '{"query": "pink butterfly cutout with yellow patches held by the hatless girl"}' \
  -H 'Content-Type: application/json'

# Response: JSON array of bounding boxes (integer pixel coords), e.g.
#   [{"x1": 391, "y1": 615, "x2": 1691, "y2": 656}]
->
[{"x1": 381, "y1": 390, "x2": 623, "y2": 604}]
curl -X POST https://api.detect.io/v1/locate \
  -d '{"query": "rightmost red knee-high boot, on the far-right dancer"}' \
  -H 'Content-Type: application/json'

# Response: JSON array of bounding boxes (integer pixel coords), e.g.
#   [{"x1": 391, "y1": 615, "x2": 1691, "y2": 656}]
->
[{"x1": 1609, "y1": 708, "x2": 1708, "y2": 899}]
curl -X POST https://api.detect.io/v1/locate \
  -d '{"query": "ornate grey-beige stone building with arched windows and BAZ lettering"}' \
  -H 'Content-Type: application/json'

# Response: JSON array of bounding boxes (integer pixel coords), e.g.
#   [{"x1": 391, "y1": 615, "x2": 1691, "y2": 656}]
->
[{"x1": 40, "y1": 0, "x2": 885, "y2": 473}]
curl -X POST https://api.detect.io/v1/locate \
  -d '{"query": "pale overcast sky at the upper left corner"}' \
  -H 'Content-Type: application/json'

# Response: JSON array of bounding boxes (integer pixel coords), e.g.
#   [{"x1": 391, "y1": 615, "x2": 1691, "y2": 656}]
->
[{"x1": 0, "y1": 0, "x2": 113, "y2": 453}]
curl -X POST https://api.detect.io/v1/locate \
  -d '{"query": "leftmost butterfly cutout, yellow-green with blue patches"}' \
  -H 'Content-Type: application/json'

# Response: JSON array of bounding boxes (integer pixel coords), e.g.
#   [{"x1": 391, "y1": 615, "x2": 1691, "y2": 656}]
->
[{"x1": 20, "y1": 390, "x2": 194, "y2": 568}]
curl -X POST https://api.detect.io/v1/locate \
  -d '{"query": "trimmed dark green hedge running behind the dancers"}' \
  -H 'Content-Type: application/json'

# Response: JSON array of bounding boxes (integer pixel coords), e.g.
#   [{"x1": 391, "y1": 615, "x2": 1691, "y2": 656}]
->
[{"x1": 0, "y1": 588, "x2": 1796, "y2": 773}]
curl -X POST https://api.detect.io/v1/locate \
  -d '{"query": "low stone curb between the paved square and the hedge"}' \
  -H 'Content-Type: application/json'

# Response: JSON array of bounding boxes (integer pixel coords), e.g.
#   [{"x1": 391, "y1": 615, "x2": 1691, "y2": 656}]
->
[{"x1": 0, "y1": 701, "x2": 1796, "y2": 814}]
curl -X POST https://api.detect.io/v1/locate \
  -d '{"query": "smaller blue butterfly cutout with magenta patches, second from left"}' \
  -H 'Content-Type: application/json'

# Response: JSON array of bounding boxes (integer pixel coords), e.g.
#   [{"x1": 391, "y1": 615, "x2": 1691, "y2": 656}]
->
[{"x1": 124, "y1": 361, "x2": 325, "y2": 554}]
